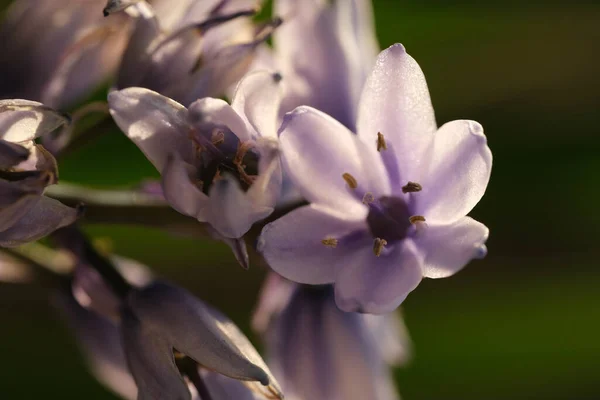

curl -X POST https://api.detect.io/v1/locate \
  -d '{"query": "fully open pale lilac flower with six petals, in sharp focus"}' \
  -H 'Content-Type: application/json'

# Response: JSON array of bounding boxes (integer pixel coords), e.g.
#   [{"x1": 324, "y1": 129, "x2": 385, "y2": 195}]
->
[{"x1": 259, "y1": 45, "x2": 492, "y2": 313}]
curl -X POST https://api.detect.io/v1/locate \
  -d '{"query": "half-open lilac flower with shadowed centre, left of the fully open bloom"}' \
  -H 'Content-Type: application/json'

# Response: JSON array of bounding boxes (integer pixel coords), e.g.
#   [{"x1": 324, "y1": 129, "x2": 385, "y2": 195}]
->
[{"x1": 108, "y1": 72, "x2": 281, "y2": 262}]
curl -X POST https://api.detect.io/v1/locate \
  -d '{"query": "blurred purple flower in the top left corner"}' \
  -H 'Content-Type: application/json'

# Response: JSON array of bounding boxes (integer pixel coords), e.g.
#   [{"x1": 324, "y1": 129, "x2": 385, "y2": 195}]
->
[{"x1": 0, "y1": 0, "x2": 129, "y2": 108}]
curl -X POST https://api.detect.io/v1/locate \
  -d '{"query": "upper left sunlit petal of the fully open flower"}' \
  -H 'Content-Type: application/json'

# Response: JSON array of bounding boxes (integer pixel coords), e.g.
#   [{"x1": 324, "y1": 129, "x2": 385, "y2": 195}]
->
[{"x1": 279, "y1": 107, "x2": 389, "y2": 217}]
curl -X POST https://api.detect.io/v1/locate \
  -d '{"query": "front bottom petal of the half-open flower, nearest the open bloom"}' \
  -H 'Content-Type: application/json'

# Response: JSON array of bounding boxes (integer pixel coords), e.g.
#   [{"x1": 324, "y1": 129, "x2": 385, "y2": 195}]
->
[{"x1": 207, "y1": 175, "x2": 273, "y2": 238}]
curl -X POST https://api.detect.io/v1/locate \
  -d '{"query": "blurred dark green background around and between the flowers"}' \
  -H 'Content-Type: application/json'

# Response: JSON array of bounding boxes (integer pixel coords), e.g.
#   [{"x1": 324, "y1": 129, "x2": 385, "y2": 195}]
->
[{"x1": 0, "y1": 0, "x2": 600, "y2": 400}]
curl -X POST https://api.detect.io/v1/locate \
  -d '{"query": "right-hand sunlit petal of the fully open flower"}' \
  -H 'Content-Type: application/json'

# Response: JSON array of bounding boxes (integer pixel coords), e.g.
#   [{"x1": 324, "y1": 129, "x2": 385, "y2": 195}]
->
[{"x1": 414, "y1": 120, "x2": 492, "y2": 223}]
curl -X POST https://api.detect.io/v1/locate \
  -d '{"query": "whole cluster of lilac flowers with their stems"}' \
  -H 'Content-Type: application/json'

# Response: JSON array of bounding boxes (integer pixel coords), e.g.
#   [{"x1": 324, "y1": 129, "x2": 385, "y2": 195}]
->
[{"x1": 0, "y1": 0, "x2": 492, "y2": 400}]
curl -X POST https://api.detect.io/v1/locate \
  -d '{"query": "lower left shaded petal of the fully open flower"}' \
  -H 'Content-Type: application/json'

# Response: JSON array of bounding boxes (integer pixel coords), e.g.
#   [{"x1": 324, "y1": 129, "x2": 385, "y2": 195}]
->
[{"x1": 258, "y1": 204, "x2": 367, "y2": 285}]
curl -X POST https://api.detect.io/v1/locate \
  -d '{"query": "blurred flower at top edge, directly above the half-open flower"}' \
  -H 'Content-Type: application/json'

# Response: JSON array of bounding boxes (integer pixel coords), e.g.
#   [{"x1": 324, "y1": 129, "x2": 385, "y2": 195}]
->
[{"x1": 105, "y1": 0, "x2": 278, "y2": 105}]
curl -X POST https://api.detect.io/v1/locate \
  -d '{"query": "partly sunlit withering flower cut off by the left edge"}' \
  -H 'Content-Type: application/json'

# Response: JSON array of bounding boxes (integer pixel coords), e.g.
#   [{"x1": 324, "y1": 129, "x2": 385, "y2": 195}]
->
[{"x1": 0, "y1": 100, "x2": 80, "y2": 247}]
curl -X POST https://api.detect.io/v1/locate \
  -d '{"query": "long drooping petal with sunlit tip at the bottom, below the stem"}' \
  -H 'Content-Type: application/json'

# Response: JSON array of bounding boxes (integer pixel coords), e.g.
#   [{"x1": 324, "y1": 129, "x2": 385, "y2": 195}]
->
[{"x1": 128, "y1": 282, "x2": 271, "y2": 385}]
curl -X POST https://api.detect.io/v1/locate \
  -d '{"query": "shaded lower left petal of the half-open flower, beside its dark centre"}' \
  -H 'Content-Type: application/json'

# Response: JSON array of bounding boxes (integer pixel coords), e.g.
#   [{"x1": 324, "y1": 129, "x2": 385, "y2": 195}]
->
[{"x1": 162, "y1": 153, "x2": 208, "y2": 221}]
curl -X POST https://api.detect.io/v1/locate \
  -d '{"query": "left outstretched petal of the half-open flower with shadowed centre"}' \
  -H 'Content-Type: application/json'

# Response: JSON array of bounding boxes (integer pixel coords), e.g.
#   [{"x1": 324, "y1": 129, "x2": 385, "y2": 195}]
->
[{"x1": 108, "y1": 87, "x2": 194, "y2": 172}]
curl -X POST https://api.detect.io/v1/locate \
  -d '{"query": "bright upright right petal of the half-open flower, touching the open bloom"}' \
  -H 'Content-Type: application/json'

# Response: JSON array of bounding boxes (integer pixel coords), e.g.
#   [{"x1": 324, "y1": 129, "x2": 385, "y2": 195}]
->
[{"x1": 231, "y1": 71, "x2": 282, "y2": 139}]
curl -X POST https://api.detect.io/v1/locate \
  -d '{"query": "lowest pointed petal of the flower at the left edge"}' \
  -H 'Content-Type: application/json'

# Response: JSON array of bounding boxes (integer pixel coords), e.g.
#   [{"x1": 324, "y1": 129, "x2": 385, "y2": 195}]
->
[{"x1": 0, "y1": 196, "x2": 81, "y2": 247}]
